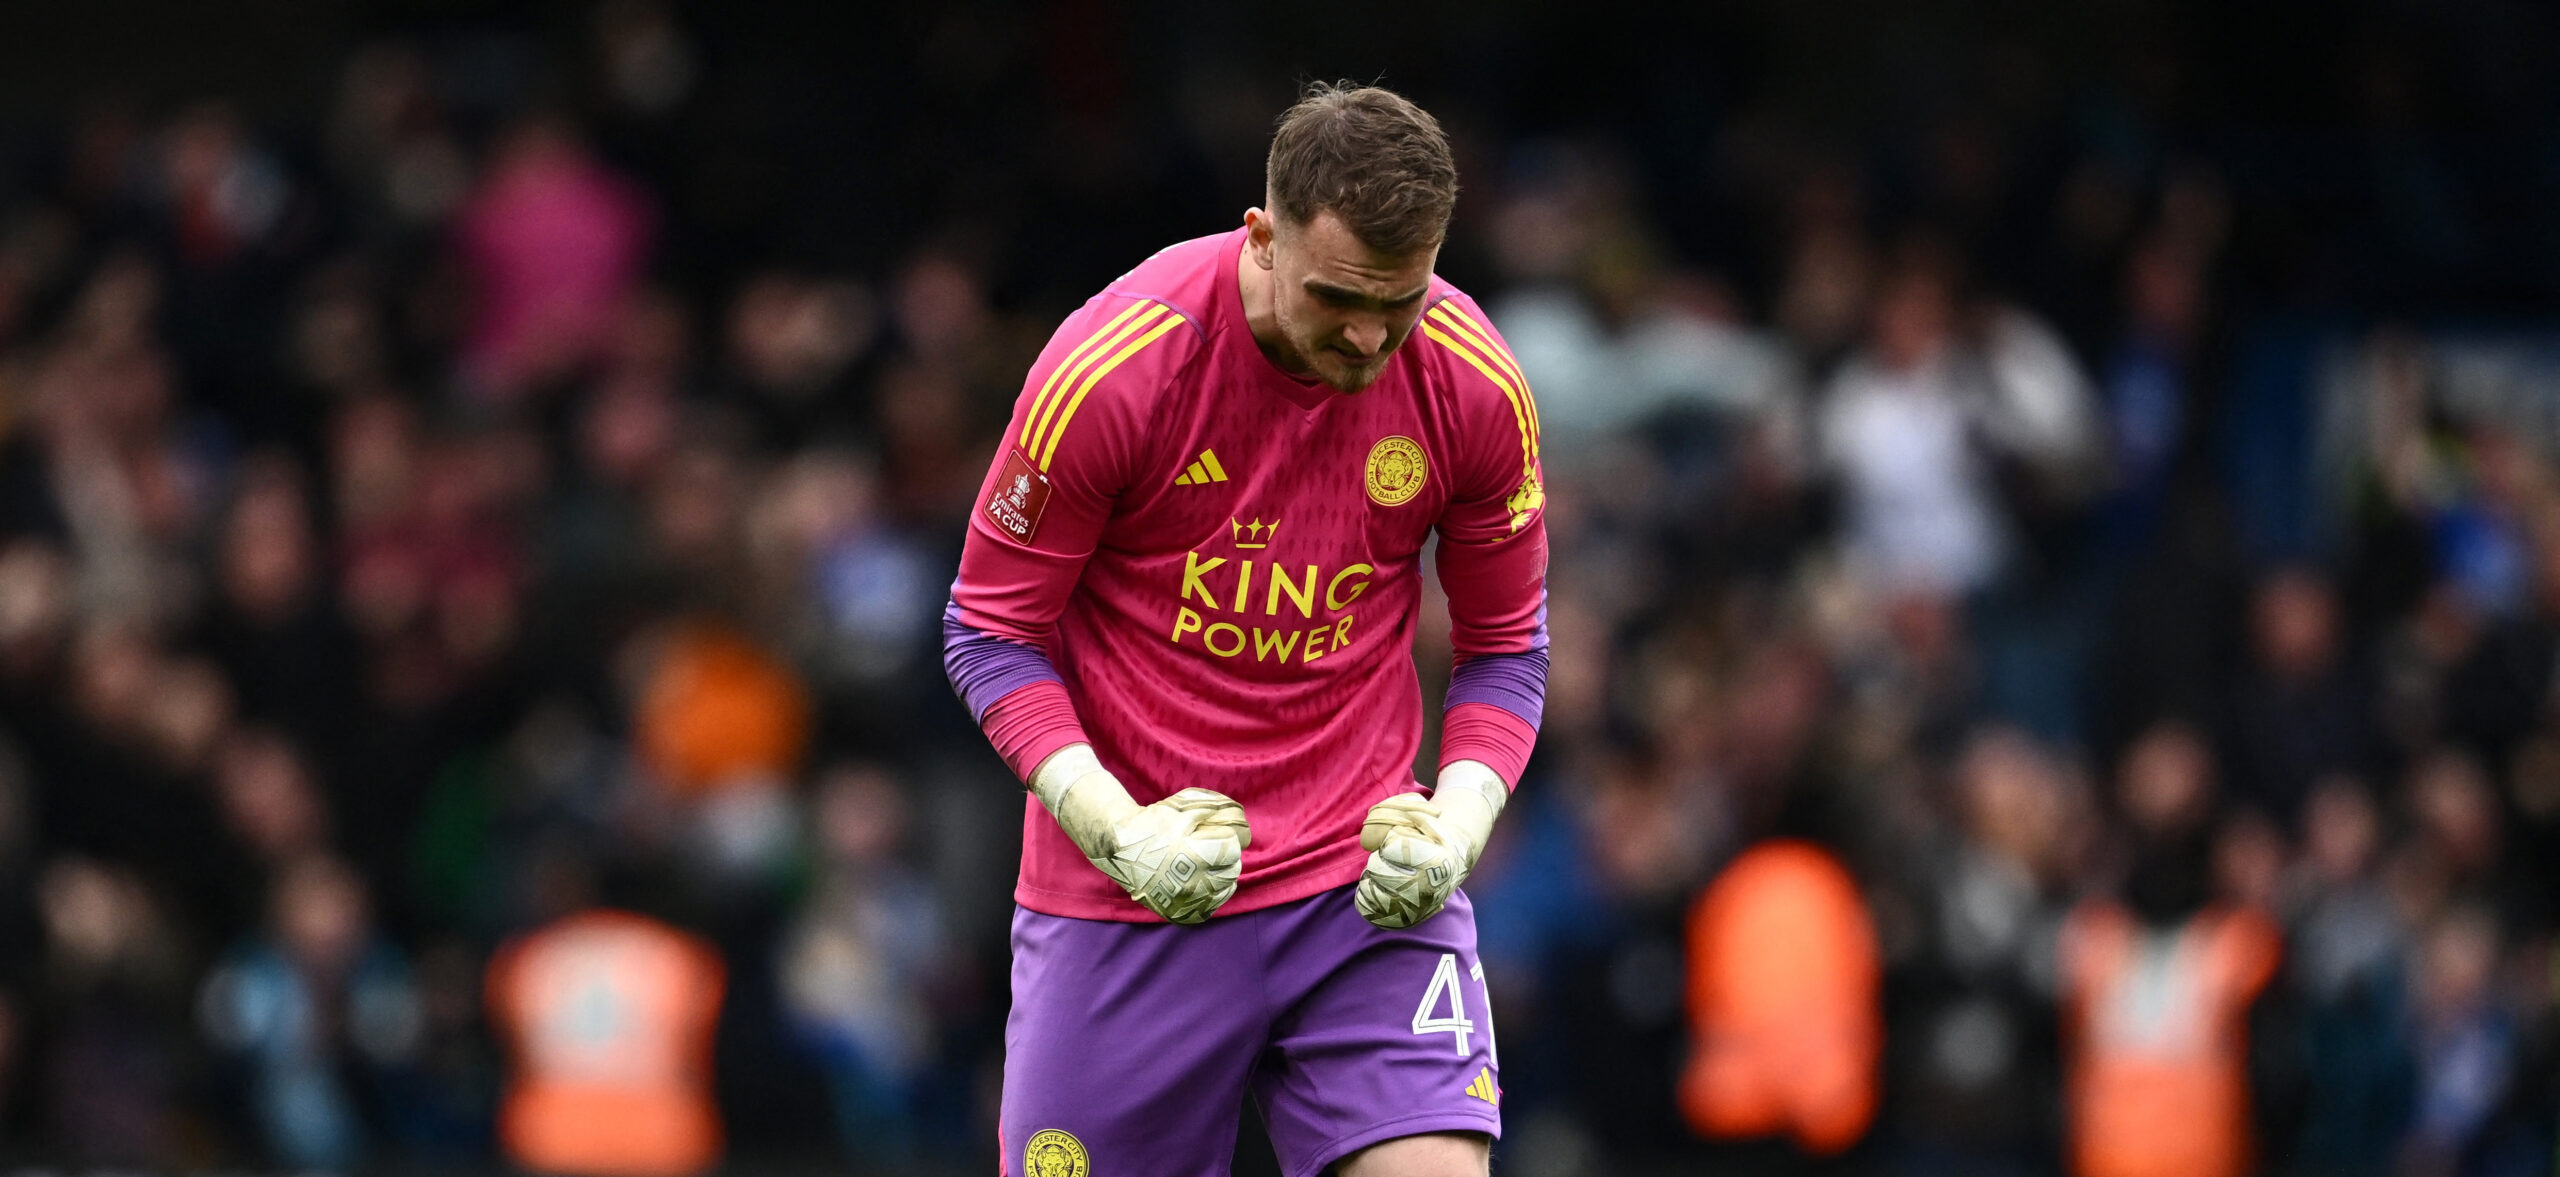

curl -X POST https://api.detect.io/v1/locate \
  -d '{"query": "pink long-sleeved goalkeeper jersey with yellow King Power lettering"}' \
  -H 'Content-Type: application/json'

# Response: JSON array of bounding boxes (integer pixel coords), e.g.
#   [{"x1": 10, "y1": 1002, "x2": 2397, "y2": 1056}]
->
[{"x1": 945, "y1": 228, "x2": 1546, "y2": 921}]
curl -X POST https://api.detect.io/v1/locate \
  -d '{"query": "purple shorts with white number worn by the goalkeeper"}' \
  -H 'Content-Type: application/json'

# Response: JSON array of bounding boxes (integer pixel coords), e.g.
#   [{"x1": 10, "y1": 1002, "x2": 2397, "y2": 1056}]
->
[{"x1": 996, "y1": 885, "x2": 1503, "y2": 1177}]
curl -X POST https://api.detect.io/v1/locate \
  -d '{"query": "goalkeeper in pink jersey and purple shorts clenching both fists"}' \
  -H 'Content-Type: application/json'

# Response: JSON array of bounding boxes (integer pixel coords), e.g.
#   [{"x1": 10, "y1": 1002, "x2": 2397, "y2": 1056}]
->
[{"x1": 945, "y1": 87, "x2": 1546, "y2": 1177}]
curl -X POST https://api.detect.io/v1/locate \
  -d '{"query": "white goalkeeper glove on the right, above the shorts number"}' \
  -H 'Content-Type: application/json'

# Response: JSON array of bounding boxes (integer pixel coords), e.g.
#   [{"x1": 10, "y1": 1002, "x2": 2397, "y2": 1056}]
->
[{"x1": 1352, "y1": 760, "x2": 1510, "y2": 929}]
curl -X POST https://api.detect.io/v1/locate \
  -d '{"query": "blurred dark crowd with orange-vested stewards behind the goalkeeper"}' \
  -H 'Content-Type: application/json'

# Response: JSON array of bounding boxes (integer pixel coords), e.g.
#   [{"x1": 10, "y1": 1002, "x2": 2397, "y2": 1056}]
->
[{"x1": 0, "y1": 0, "x2": 2560, "y2": 1177}]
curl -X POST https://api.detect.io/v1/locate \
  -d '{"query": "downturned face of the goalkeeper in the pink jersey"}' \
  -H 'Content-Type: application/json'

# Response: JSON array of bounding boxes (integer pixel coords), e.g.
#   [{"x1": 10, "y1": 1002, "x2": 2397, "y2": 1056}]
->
[{"x1": 1249, "y1": 210, "x2": 1439, "y2": 391}]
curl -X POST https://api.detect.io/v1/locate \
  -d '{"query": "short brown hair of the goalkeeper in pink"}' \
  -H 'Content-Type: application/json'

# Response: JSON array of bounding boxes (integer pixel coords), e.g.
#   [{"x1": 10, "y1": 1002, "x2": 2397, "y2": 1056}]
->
[{"x1": 1265, "y1": 82, "x2": 1457, "y2": 253}]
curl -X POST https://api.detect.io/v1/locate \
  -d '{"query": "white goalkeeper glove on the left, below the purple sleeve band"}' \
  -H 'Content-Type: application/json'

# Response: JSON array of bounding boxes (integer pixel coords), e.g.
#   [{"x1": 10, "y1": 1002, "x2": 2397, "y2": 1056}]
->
[{"x1": 1032, "y1": 745, "x2": 1254, "y2": 924}]
